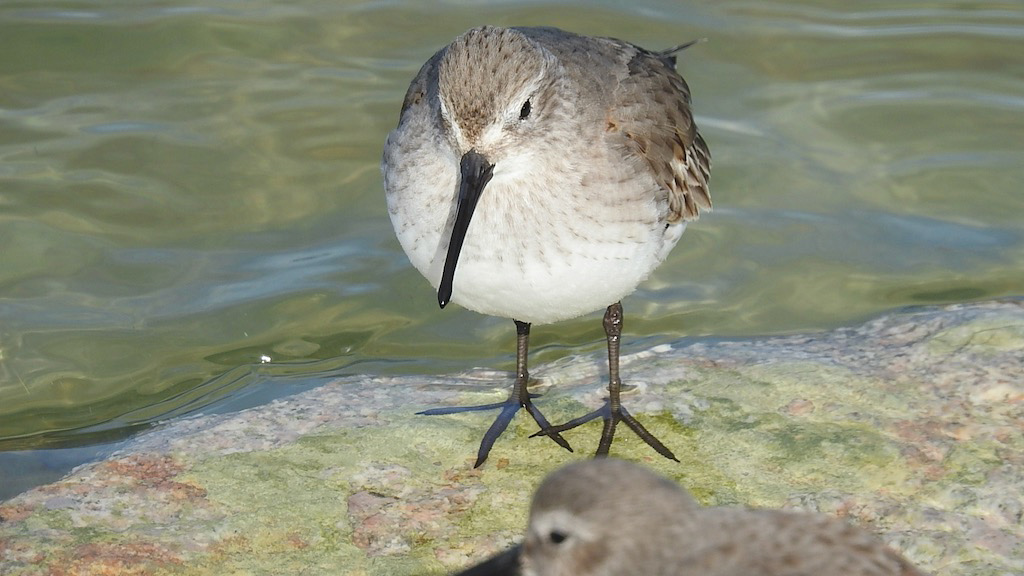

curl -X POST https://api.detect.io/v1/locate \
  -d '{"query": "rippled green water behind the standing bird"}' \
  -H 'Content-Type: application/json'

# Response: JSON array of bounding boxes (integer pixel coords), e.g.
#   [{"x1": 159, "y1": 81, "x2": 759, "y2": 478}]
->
[{"x1": 0, "y1": 0, "x2": 1024, "y2": 498}]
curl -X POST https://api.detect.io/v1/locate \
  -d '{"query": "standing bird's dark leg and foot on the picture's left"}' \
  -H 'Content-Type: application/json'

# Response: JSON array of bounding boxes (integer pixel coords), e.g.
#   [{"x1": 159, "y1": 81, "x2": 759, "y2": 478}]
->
[{"x1": 417, "y1": 320, "x2": 572, "y2": 468}]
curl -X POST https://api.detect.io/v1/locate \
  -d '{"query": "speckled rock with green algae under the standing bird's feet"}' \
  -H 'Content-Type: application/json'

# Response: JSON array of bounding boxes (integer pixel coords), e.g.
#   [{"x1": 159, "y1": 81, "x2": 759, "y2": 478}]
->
[{"x1": 0, "y1": 302, "x2": 1024, "y2": 576}]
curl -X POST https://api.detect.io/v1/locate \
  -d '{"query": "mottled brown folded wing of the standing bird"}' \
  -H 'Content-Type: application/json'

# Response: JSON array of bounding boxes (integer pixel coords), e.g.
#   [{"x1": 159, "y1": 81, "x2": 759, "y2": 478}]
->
[{"x1": 608, "y1": 43, "x2": 712, "y2": 222}]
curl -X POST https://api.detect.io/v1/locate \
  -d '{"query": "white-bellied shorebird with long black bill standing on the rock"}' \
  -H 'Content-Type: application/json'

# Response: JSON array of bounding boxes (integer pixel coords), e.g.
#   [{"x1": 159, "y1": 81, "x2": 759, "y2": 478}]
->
[{"x1": 382, "y1": 27, "x2": 711, "y2": 466}]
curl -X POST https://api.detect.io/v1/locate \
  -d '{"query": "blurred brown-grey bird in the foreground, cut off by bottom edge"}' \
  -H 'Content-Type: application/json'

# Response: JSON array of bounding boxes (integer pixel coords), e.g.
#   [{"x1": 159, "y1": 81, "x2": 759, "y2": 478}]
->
[{"x1": 459, "y1": 458, "x2": 923, "y2": 576}]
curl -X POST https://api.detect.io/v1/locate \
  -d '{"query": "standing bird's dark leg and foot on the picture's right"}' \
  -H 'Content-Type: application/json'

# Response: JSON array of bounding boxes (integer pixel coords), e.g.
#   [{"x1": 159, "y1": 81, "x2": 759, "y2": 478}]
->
[{"x1": 534, "y1": 302, "x2": 679, "y2": 462}]
